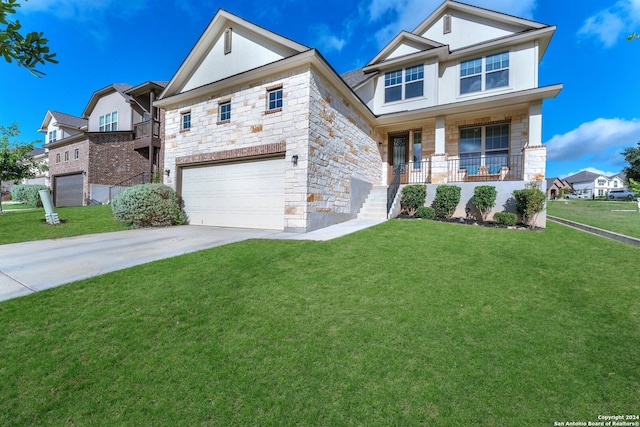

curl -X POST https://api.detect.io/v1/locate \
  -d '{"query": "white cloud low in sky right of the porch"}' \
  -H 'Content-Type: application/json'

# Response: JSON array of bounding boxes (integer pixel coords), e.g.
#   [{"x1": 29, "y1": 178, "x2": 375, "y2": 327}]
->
[{"x1": 546, "y1": 118, "x2": 640, "y2": 163}]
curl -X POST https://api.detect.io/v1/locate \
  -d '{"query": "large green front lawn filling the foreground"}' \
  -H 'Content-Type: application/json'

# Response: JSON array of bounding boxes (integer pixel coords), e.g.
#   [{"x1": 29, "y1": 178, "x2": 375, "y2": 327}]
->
[{"x1": 0, "y1": 220, "x2": 640, "y2": 426}]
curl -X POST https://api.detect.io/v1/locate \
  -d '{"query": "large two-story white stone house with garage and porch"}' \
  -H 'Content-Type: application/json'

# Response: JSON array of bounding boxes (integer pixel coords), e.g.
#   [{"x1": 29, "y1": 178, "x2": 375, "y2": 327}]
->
[{"x1": 156, "y1": 0, "x2": 562, "y2": 232}]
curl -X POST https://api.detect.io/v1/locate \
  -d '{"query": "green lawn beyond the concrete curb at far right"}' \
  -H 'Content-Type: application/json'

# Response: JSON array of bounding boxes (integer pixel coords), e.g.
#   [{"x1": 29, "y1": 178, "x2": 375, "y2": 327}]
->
[{"x1": 547, "y1": 199, "x2": 640, "y2": 238}]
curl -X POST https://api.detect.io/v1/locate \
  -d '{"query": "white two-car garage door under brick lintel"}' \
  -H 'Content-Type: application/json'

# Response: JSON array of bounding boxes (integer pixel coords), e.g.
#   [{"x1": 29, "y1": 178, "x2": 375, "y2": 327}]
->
[{"x1": 182, "y1": 158, "x2": 285, "y2": 230}]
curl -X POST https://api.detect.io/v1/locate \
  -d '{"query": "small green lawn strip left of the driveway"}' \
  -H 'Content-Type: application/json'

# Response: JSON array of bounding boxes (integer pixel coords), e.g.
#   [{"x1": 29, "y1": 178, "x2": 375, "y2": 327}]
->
[{"x1": 0, "y1": 205, "x2": 127, "y2": 245}]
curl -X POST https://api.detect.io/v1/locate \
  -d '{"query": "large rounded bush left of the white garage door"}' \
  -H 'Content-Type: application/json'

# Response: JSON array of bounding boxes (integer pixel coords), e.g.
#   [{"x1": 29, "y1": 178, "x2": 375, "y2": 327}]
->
[{"x1": 111, "y1": 184, "x2": 187, "y2": 228}]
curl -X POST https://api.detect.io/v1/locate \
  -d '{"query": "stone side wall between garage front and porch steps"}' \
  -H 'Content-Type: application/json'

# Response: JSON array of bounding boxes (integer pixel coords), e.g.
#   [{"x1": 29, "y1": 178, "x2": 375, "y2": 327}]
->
[{"x1": 306, "y1": 71, "x2": 382, "y2": 230}]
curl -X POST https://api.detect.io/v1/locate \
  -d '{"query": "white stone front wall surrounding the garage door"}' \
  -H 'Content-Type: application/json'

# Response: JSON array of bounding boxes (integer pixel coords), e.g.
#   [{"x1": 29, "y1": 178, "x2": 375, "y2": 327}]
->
[{"x1": 164, "y1": 67, "x2": 310, "y2": 230}]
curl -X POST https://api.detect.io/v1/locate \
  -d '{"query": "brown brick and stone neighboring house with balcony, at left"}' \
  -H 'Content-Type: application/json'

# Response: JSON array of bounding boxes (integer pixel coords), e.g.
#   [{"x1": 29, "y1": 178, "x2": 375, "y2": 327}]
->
[{"x1": 39, "y1": 82, "x2": 166, "y2": 206}]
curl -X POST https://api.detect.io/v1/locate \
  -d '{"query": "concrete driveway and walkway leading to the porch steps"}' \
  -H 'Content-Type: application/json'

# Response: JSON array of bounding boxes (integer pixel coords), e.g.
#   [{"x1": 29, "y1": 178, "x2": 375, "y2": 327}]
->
[{"x1": 0, "y1": 219, "x2": 384, "y2": 301}]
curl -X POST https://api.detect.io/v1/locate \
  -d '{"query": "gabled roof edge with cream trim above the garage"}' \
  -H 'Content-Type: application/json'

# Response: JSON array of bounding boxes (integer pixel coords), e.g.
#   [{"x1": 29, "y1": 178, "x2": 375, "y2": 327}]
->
[{"x1": 159, "y1": 9, "x2": 309, "y2": 99}]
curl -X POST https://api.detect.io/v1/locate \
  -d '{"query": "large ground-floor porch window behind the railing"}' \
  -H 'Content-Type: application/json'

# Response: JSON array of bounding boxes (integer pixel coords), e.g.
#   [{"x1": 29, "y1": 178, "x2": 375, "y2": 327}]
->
[{"x1": 460, "y1": 123, "x2": 509, "y2": 175}]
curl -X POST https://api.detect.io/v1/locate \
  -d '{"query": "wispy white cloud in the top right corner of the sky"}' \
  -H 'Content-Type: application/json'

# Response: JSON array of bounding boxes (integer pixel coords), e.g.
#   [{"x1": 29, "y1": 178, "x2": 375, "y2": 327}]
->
[{"x1": 578, "y1": 0, "x2": 640, "y2": 48}]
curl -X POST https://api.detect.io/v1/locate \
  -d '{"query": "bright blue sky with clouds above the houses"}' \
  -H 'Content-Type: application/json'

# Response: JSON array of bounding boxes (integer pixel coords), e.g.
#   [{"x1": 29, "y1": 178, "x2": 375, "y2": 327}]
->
[{"x1": 0, "y1": 0, "x2": 640, "y2": 177}]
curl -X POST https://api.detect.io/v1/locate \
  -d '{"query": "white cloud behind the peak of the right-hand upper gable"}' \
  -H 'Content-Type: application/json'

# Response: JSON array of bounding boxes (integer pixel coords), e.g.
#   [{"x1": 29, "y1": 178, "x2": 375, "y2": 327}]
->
[{"x1": 360, "y1": 0, "x2": 536, "y2": 47}]
